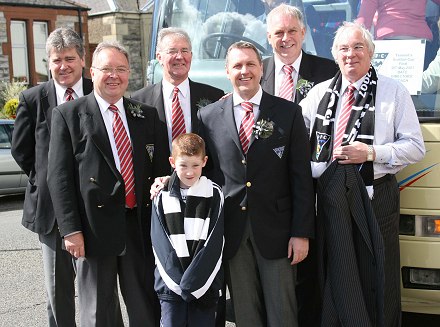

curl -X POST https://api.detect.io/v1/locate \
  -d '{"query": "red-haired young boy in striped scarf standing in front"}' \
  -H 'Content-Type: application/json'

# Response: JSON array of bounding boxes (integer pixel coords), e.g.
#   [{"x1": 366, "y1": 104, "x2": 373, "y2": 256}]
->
[{"x1": 151, "y1": 133, "x2": 224, "y2": 327}]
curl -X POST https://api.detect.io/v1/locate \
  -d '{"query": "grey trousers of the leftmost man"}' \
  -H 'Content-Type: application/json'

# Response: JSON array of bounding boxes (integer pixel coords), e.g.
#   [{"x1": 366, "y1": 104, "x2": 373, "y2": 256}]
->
[{"x1": 39, "y1": 225, "x2": 75, "y2": 327}]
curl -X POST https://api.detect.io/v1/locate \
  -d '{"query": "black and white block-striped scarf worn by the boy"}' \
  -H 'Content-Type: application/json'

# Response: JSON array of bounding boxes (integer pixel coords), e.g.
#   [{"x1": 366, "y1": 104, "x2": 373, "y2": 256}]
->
[{"x1": 159, "y1": 172, "x2": 218, "y2": 270}]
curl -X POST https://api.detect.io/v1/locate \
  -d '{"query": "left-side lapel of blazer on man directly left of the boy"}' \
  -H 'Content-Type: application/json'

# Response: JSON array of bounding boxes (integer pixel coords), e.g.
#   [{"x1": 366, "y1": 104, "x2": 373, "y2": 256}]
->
[{"x1": 82, "y1": 93, "x2": 123, "y2": 182}]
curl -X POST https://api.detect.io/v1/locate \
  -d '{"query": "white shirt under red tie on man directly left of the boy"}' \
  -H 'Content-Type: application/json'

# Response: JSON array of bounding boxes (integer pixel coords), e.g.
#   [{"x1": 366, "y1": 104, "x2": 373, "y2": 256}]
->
[{"x1": 94, "y1": 92, "x2": 131, "y2": 172}]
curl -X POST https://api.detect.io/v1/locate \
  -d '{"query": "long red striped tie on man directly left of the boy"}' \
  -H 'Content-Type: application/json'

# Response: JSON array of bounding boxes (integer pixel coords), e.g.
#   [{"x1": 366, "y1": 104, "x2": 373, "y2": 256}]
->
[{"x1": 108, "y1": 104, "x2": 136, "y2": 208}]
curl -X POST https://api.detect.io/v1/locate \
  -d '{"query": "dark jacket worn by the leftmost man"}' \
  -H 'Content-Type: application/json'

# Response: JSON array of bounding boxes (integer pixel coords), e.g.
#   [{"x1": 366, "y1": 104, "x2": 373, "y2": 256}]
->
[{"x1": 11, "y1": 78, "x2": 93, "y2": 234}]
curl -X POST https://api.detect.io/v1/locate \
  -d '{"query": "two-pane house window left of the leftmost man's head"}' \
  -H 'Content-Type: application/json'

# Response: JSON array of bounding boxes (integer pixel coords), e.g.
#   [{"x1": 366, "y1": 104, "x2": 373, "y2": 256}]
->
[{"x1": 11, "y1": 20, "x2": 49, "y2": 84}]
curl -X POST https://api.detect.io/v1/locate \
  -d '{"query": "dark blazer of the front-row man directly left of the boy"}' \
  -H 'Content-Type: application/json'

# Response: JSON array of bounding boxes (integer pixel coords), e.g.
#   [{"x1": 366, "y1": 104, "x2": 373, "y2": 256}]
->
[{"x1": 48, "y1": 93, "x2": 170, "y2": 256}]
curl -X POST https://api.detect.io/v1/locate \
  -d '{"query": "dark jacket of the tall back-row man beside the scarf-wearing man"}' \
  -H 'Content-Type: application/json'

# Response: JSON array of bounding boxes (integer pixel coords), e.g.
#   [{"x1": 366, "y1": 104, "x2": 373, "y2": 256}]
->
[{"x1": 261, "y1": 51, "x2": 338, "y2": 103}]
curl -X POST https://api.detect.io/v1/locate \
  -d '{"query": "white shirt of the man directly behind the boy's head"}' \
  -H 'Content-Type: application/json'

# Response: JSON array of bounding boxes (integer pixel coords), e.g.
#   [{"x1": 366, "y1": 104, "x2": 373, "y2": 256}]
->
[{"x1": 162, "y1": 78, "x2": 191, "y2": 149}]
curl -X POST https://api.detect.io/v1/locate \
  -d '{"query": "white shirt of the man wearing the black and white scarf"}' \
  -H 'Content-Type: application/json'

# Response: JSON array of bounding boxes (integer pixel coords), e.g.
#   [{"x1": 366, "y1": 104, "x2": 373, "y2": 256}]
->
[{"x1": 300, "y1": 75, "x2": 425, "y2": 179}]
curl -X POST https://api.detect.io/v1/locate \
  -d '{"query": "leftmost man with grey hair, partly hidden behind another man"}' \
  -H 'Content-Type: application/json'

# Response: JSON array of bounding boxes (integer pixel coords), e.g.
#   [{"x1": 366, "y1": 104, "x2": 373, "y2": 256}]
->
[{"x1": 11, "y1": 28, "x2": 93, "y2": 327}]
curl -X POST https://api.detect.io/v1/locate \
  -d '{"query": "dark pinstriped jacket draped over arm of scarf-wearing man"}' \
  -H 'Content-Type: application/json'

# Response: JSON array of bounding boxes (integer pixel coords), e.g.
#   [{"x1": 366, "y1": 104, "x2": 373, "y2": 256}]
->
[{"x1": 317, "y1": 161, "x2": 385, "y2": 327}]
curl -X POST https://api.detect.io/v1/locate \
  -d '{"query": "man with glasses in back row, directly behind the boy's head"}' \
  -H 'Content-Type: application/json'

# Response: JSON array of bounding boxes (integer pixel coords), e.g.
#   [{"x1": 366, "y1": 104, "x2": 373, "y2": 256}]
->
[{"x1": 132, "y1": 27, "x2": 224, "y2": 149}]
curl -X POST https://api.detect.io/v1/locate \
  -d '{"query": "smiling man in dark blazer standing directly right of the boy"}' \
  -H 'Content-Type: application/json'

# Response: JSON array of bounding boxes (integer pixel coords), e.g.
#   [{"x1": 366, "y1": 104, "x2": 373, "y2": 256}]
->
[{"x1": 199, "y1": 42, "x2": 314, "y2": 327}]
